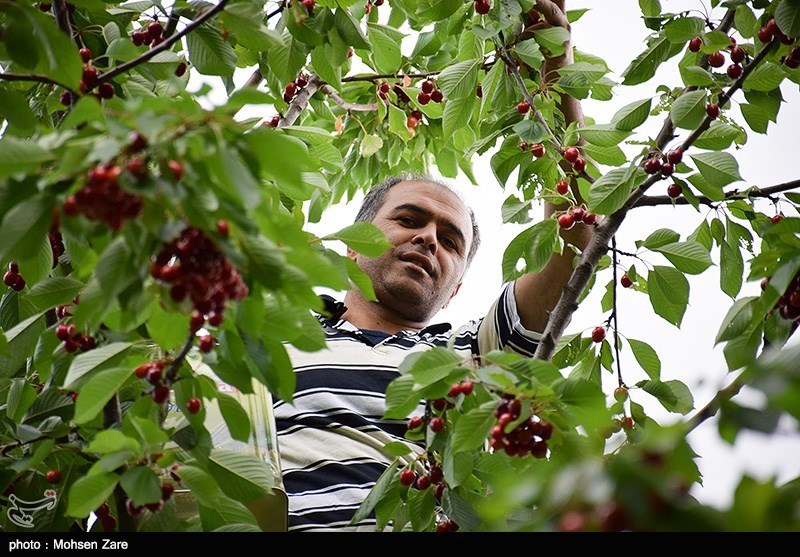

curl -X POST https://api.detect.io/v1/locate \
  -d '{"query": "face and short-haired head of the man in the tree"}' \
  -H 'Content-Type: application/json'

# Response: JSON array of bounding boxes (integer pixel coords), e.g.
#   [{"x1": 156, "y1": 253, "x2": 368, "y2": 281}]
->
[{"x1": 348, "y1": 181, "x2": 472, "y2": 323}]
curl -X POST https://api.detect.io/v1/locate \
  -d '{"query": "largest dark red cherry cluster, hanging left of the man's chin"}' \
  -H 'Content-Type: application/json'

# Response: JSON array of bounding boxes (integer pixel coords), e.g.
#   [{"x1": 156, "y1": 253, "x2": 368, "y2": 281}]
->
[{"x1": 150, "y1": 224, "x2": 248, "y2": 346}]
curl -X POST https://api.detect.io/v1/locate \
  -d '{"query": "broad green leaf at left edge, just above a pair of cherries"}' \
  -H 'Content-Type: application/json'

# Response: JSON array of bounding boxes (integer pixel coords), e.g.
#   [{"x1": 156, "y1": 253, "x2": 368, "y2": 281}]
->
[{"x1": 0, "y1": 191, "x2": 53, "y2": 262}]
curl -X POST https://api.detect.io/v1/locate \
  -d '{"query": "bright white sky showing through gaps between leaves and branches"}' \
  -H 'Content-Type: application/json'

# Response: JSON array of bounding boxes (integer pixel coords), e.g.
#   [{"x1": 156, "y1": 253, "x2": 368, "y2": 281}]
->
[{"x1": 212, "y1": 0, "x2": 800, "y2": 508}]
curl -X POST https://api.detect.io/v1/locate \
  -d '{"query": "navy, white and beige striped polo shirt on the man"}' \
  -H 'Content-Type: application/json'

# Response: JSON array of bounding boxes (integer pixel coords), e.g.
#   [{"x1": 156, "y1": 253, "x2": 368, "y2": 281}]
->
[{"x1": 275, "y1": 283, "x2": 541, "y2": 532}]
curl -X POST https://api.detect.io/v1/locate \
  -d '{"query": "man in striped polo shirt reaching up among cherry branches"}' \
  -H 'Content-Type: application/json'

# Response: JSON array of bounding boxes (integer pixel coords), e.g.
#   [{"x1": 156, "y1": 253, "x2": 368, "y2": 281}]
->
[{"x1": 275, "y1": 176, "x2": 591, "y2": 531}]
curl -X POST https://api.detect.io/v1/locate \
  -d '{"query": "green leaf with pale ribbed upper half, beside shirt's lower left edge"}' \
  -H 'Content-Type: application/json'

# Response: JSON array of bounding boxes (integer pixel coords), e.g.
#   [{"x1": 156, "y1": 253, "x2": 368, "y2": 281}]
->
[{"x1": 208, "y1": 449, "x2": 275, "y2": 503}]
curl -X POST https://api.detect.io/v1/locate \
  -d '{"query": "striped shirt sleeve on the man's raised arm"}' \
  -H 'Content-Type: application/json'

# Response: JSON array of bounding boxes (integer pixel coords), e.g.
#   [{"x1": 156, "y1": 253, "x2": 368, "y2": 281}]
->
[{"x1": 478, "y1": 282, "x2": 542, "y2": 357}]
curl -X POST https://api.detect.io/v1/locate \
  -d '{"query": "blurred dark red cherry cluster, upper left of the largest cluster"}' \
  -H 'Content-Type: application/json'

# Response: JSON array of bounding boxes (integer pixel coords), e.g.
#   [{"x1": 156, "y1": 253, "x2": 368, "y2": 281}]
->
[{"x1": 63, "y1": 157, "x2": 142, "y2": 231}]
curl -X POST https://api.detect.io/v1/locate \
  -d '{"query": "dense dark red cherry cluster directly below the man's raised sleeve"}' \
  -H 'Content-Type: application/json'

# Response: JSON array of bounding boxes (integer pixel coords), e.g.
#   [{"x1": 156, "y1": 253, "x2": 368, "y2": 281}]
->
[{"x1": 489, "y1": 393, "x2": 553, "y2": 458}]
